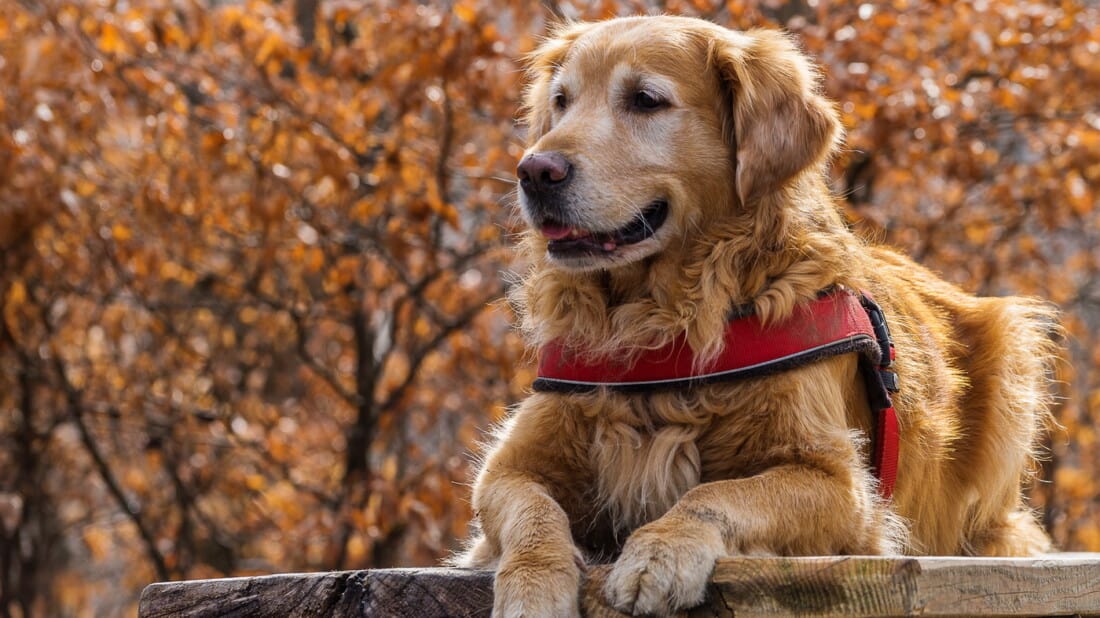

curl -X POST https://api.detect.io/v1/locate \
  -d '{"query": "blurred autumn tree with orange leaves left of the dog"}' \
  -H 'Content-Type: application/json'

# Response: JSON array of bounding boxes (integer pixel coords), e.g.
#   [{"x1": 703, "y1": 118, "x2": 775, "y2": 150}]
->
[{"x1": 0, "y1": 2, "x2": 536, "y2": 615}]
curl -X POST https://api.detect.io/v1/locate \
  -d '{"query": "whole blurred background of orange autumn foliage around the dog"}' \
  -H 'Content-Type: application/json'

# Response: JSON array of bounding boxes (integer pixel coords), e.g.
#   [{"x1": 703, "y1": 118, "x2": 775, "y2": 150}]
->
[{"x1": 0, "y1": 0, "x2": 1100, "y2": 618}]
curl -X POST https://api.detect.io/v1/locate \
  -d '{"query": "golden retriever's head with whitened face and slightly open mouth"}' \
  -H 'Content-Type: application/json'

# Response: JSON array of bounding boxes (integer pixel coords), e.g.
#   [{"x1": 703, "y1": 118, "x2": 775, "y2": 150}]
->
[{"x1": 517, "y1": 16, "x2": 839, "y2": 271}]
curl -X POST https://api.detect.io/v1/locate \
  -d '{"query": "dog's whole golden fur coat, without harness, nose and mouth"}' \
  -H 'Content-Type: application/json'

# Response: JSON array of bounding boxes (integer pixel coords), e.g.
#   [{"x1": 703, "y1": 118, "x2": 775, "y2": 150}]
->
[{"x1": 458, "y1": 16, "x2": 1056, "y2": 617}]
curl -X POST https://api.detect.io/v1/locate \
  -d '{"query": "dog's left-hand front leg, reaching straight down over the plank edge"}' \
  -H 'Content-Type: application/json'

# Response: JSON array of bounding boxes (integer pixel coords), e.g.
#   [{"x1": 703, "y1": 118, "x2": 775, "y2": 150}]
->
[{"x1": 475, "y1": 470, "x2": 584, "y2": 618}]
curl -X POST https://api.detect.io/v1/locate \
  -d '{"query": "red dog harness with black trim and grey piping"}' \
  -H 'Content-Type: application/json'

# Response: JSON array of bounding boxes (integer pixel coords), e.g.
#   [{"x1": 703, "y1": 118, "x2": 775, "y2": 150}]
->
[{"x1": 534, "y1": 288, "x2": 898, "y2": 498}]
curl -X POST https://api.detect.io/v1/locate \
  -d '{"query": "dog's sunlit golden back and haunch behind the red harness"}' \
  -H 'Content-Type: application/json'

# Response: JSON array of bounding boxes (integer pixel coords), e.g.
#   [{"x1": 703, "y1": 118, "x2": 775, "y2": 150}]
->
[{"x1": 867, "y1": 247, "x2": 1058, "y2": 555}]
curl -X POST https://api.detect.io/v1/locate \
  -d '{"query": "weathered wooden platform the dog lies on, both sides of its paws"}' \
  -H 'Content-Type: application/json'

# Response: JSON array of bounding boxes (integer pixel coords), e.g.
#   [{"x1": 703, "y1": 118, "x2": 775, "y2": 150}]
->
[{"x1": 139, "y1": 554, "x2": 1100, "y2": 618}]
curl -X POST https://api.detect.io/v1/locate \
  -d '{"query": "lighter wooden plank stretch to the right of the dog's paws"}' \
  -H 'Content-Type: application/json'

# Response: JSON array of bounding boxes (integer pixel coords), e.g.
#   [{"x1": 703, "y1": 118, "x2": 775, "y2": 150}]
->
[{"x1": 711, "y1": 554, "x2": 1100, "y2": 616}]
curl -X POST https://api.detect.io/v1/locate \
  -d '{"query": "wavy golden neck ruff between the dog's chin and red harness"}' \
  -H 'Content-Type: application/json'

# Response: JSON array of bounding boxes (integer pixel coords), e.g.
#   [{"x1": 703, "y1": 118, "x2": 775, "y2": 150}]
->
[{"x1": 513, "y1": 181, "x2": 858, "y2": 361}]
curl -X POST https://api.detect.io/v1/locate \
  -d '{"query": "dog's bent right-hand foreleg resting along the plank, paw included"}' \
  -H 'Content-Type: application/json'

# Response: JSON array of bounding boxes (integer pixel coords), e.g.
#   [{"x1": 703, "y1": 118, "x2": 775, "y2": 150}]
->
[{"x1": 604, "y1": 464, "x2": 888, "y2": 615}]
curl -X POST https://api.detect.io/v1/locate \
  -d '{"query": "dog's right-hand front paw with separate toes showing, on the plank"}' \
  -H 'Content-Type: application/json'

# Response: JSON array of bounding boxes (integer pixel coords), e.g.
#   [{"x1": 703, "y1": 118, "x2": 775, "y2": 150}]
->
[{"x1": 604, "y1": 527, "x2": 722, "y2": 616}]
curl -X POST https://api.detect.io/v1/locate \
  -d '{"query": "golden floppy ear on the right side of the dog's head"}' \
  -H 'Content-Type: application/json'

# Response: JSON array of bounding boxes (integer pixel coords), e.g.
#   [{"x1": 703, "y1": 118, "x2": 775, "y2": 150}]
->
[{"x1": 712, "y1": 30, "x2": 840, "y2": 205}]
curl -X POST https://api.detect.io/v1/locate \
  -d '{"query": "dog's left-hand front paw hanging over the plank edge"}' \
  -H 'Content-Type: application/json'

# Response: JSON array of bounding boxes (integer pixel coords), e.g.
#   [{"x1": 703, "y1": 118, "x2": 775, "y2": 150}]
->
[{"x1": 493, "y1": 552, "x2": 584, "y2": 618}]
